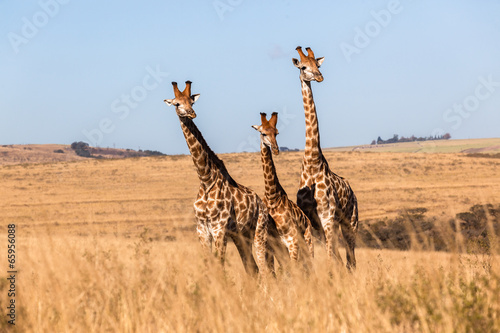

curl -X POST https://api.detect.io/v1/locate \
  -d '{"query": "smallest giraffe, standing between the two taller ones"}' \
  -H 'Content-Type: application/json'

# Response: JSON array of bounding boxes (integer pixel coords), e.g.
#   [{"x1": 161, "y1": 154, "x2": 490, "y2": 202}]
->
[{"x1": 252, "y1": 112, "x2": 314, "y2": 268}]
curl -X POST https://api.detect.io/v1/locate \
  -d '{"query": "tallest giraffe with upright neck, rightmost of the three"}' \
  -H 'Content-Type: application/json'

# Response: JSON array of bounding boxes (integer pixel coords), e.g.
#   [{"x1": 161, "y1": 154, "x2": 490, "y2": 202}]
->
[{"x1": 292, "y1": 46, "x2": 358, "y2": 270}]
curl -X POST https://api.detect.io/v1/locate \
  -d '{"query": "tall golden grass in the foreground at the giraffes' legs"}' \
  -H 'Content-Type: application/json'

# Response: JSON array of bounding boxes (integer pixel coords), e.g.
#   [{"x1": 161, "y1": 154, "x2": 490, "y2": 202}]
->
[{"x1": 0, "y1": 228, "x2": 500, "y2": 332}]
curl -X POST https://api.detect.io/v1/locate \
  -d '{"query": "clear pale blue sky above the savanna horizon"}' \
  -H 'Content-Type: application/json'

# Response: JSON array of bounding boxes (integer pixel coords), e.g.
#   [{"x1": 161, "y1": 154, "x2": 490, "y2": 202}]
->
[{"x1": 0, "y1": 0, "x2": 500, "y2": 154}]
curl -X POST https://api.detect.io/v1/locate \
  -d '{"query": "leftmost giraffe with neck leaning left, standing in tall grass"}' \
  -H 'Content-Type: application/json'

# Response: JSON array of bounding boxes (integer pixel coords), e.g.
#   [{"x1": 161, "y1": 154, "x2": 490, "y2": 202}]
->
[{"x1": 164, "y1": 81, "x2": 274, "y2": 275}]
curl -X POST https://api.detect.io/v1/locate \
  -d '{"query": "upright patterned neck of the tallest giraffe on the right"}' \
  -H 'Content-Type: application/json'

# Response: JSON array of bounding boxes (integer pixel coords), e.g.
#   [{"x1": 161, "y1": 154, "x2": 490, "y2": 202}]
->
[{"x1": 301, "y1": 80, "x2": 323, "y2": 164}]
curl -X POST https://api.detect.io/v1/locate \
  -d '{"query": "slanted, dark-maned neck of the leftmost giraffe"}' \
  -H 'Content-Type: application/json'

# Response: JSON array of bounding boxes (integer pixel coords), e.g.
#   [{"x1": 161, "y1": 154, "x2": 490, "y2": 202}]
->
[{"x1": 179, "y1": 117, "x2": 236, "y2": 186}]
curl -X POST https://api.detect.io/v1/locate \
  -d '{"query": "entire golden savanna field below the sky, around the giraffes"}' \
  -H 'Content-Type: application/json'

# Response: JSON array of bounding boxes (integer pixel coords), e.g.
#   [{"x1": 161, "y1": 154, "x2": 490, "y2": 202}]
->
[{"x1": 0, "y1": 139, "x2": 500, "y2": 332}]
